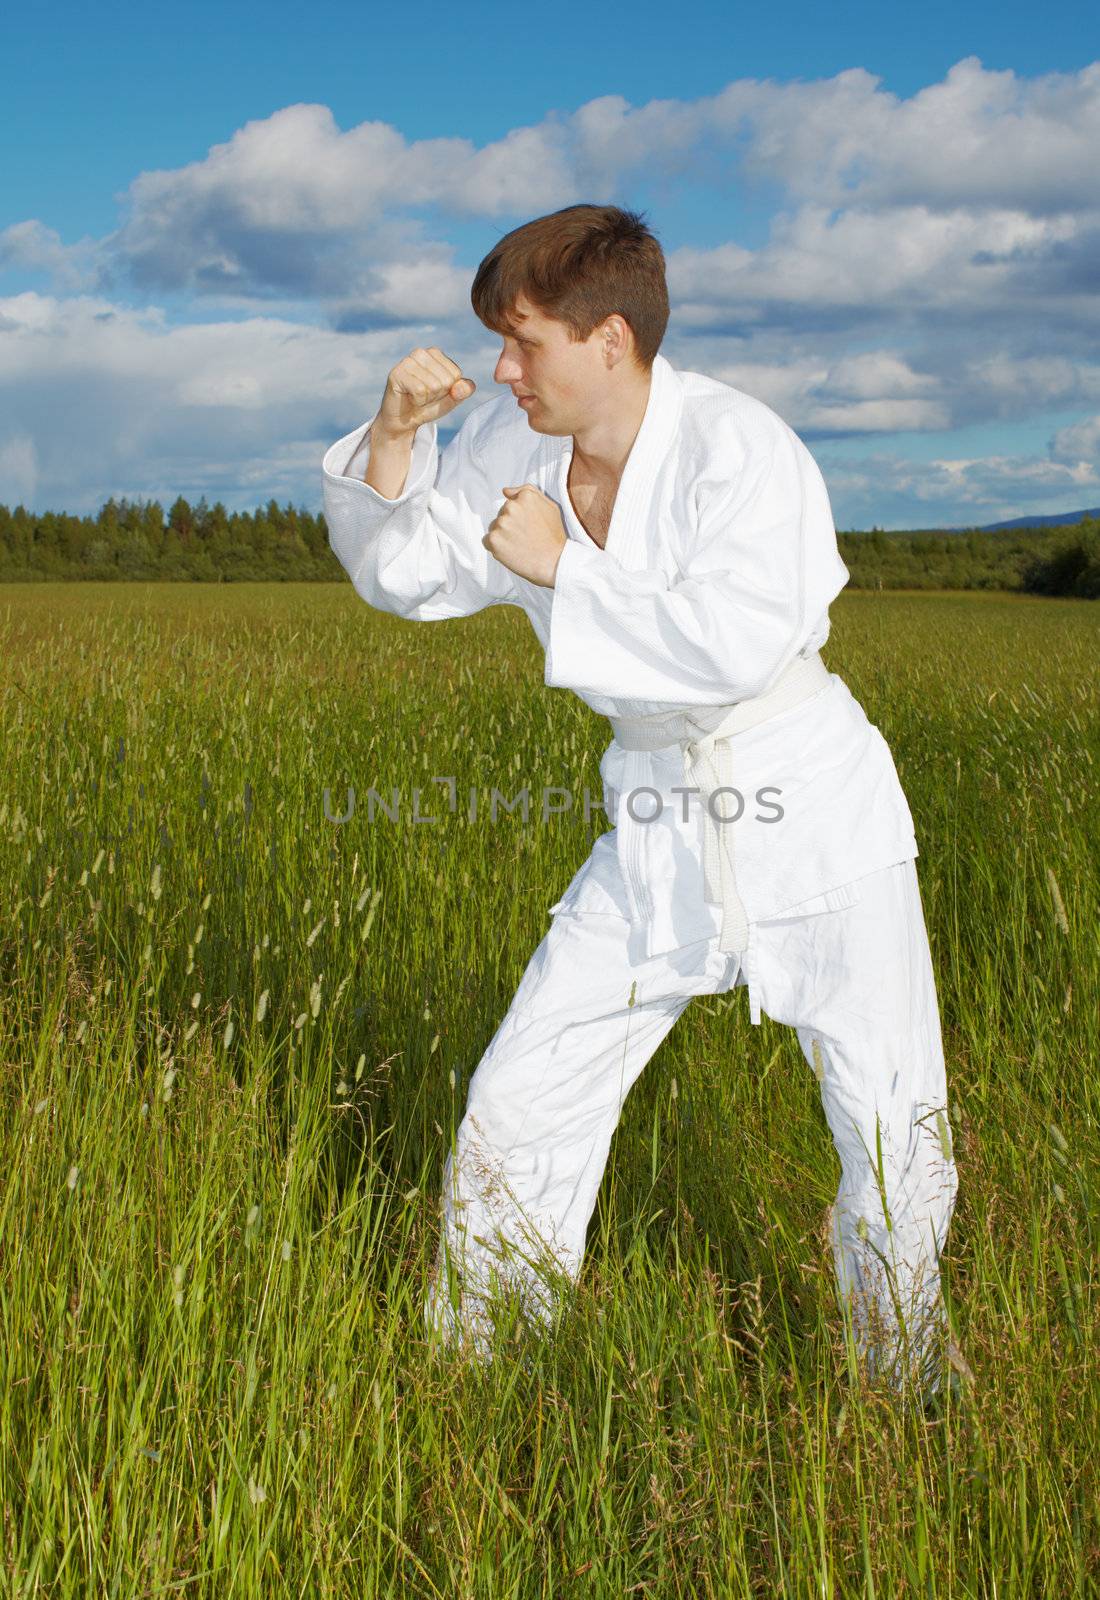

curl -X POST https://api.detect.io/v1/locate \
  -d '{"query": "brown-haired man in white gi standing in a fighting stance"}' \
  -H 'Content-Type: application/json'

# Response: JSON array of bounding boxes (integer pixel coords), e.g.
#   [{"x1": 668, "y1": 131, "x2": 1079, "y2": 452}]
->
[{"x1": 323, "y1": 205, "x2": 958, "y2": 1390}]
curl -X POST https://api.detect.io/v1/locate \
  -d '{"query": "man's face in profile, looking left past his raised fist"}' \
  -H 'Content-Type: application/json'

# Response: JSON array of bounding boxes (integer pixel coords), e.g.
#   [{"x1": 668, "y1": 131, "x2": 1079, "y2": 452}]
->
[{"x1": 492, "y1": 294, "x2": 609, "y2": 435}]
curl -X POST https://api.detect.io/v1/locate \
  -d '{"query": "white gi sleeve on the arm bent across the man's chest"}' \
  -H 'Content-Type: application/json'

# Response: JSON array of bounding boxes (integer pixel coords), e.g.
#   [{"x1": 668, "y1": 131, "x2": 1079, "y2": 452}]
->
[{"x1": 545, "y1": 424, "x2": 849, "y2": 706}]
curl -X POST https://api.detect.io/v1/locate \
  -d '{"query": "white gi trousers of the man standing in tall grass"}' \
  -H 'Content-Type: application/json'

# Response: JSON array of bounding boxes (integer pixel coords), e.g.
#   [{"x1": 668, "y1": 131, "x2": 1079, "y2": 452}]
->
[{"x1": 424, "y1": 859, "x2": 958, "y2": 1390}]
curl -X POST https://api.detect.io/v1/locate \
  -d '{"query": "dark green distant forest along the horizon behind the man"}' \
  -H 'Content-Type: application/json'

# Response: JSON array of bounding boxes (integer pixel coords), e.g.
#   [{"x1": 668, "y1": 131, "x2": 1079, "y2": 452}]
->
[{"x1": 0, "y1": 496, "x2": 1100, "y2": 600}]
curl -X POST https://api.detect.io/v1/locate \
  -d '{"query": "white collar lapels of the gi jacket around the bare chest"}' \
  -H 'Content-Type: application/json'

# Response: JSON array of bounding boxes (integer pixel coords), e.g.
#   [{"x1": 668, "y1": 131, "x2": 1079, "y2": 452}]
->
[{"x1": 540, "y1": 352, "x2": 683, "y2": 570}]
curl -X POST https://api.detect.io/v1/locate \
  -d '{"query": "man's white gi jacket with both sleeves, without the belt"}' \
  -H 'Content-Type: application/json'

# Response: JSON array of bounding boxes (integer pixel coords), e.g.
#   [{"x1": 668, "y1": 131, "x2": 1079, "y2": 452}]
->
[{"x1": 323, "y1": 355, "x2": 918, "y2": 960}]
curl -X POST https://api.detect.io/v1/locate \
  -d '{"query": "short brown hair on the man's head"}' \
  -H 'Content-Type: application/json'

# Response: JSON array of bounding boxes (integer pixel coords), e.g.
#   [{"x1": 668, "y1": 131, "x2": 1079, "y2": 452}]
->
[{"x1": 470, "y1": 205, "x2": 668, "y2": 371}]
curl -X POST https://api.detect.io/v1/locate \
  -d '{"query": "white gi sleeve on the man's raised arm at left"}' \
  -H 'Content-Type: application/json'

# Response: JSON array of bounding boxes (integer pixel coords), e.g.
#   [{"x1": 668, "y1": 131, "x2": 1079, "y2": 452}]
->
[{"x1": 321, "y1": 408, "x2": 521, "y2": 622}]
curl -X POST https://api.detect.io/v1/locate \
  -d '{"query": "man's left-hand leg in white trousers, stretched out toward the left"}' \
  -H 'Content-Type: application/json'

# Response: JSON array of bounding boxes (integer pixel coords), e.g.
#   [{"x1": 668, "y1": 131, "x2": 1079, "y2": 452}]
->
[{"x1": 424, "y1": 912, "x2": 737, "y2": 1358}]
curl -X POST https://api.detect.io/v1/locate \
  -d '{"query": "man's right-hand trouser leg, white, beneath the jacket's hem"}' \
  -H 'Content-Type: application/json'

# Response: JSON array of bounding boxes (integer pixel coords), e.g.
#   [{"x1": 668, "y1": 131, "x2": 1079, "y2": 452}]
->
[{"x1": 758, "y1": 861, "x2": 958, "y2": 1390}]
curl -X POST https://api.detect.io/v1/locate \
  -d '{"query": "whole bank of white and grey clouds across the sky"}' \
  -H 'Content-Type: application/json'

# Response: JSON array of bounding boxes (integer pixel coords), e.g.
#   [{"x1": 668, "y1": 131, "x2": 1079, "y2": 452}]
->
[{"x1": 0, "y1": 59, "x2": 1100, "y2": 522}]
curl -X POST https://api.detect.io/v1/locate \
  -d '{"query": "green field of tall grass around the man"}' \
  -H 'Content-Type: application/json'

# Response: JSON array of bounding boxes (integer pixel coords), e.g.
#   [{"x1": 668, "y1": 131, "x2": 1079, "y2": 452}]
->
[{"x1": 0, "y1": 582, "x2": 1100, "y2": 1600}]
